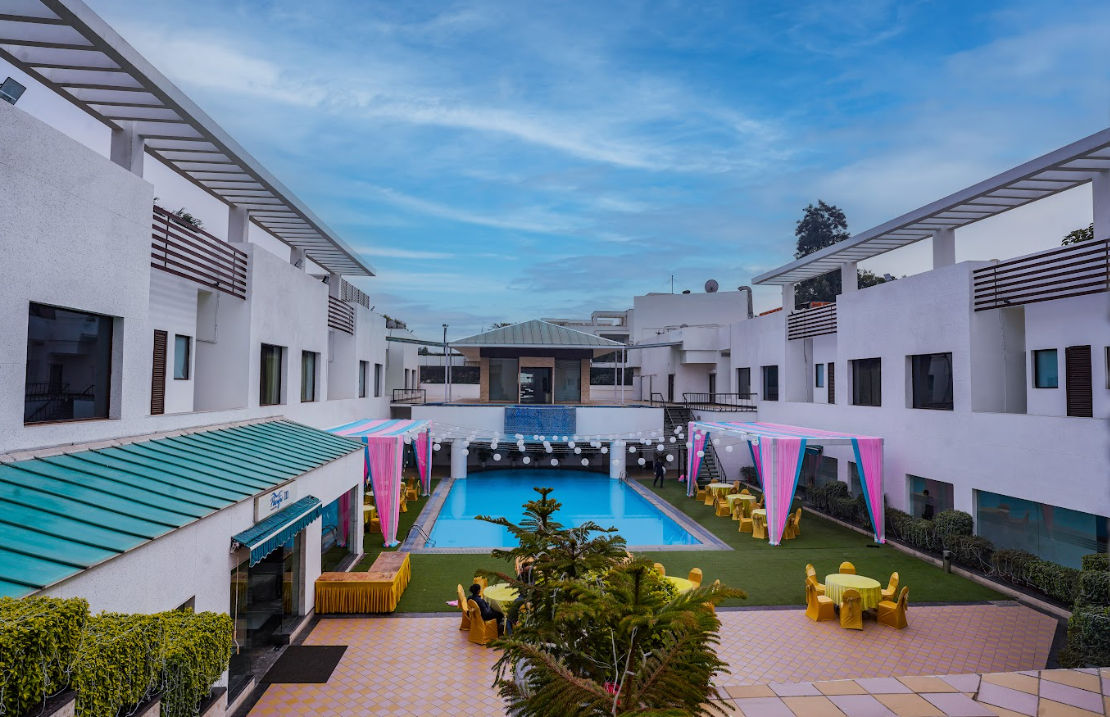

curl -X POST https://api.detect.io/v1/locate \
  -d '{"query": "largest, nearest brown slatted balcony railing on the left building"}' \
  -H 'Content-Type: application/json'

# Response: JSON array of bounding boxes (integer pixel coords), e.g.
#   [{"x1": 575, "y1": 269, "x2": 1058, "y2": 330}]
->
[{"x1": 150, "y1": 206, "x2": 248, "y2": 299}]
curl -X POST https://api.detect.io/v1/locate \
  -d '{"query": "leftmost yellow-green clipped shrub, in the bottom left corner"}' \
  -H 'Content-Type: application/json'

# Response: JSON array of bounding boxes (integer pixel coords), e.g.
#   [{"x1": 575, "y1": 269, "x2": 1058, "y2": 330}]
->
[{"x1": 0, "y1": 597, "x2": 89, "y2": 715}]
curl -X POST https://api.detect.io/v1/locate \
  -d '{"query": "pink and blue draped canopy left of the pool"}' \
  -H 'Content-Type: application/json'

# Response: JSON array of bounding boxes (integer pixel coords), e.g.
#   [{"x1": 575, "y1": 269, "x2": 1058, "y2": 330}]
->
[{"x1": 331, "y1": 418, "x2": 432, "y2": 547}]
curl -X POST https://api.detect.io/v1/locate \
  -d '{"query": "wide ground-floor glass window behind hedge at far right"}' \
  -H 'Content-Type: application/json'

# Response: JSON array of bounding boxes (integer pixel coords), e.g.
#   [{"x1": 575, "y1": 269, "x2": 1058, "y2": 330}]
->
[{"x1": 976, "y1": 491, "x2": 1108, "y2": 568}]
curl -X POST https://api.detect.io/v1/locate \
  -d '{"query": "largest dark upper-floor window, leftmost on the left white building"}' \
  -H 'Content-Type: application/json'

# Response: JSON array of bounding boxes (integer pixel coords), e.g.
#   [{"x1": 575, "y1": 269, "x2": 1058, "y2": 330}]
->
[{"x1": 23, "y1": 304, "x2": 114, "y2": 423}]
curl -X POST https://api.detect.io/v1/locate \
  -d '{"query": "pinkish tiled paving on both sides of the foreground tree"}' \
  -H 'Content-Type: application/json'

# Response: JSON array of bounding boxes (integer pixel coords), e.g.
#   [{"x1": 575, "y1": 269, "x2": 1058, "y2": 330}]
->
[{"x1": 251, "y1": 605, "x2": 1061, "y2": 717}]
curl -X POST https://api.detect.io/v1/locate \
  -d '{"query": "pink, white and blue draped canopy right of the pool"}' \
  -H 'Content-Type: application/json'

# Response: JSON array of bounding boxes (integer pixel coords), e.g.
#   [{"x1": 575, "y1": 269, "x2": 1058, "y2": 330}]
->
[{"x1": 688, "y1": 421, "x2": 886, "y2": 545}]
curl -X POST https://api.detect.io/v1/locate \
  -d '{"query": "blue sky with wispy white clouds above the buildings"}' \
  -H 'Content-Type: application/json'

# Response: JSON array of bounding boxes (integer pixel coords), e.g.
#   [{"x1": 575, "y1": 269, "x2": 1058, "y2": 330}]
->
[{"x1": 10, "y1": 0, "x2": 1110, "y2": 336}]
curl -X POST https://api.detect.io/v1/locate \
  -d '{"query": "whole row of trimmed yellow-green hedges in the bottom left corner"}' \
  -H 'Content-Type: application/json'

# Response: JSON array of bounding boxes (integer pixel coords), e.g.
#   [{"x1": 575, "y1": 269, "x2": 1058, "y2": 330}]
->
[{"x1": 0, "y1": 598, "x2": 232, "y2": 717}]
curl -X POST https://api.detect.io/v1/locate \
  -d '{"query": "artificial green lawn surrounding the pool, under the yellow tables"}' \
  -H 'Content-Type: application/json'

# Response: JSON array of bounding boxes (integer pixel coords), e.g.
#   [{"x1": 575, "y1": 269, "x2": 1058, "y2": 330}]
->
[{"x1": 354, "y1": 479, "x2": 1003, "y2": 613}]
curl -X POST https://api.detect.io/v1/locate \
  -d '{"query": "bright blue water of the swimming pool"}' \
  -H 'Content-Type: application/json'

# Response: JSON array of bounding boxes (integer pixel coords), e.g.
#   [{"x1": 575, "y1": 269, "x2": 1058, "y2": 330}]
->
[{"x1": 431, "y1": 469, "x2": 698, "y2": 548}]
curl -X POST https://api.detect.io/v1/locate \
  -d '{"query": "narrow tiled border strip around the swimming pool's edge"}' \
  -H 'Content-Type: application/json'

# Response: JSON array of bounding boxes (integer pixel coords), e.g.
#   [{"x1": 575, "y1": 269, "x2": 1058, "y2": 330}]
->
[{"x1": 401, "y1": 474, "x2": 733, "y2": 555}]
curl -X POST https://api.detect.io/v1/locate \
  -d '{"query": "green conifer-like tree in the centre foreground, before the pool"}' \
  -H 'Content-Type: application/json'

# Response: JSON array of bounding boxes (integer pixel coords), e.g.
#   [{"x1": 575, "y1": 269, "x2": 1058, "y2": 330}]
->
[{"x1": 478, "y1": 488, "x2": 745, "y2": 717}]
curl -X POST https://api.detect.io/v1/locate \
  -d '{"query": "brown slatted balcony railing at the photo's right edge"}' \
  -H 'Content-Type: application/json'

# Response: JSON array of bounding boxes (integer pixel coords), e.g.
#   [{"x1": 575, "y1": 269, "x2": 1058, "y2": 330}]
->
[{"x1": 971, "y1": 239, "x2": 1110, "y2": 311}]
